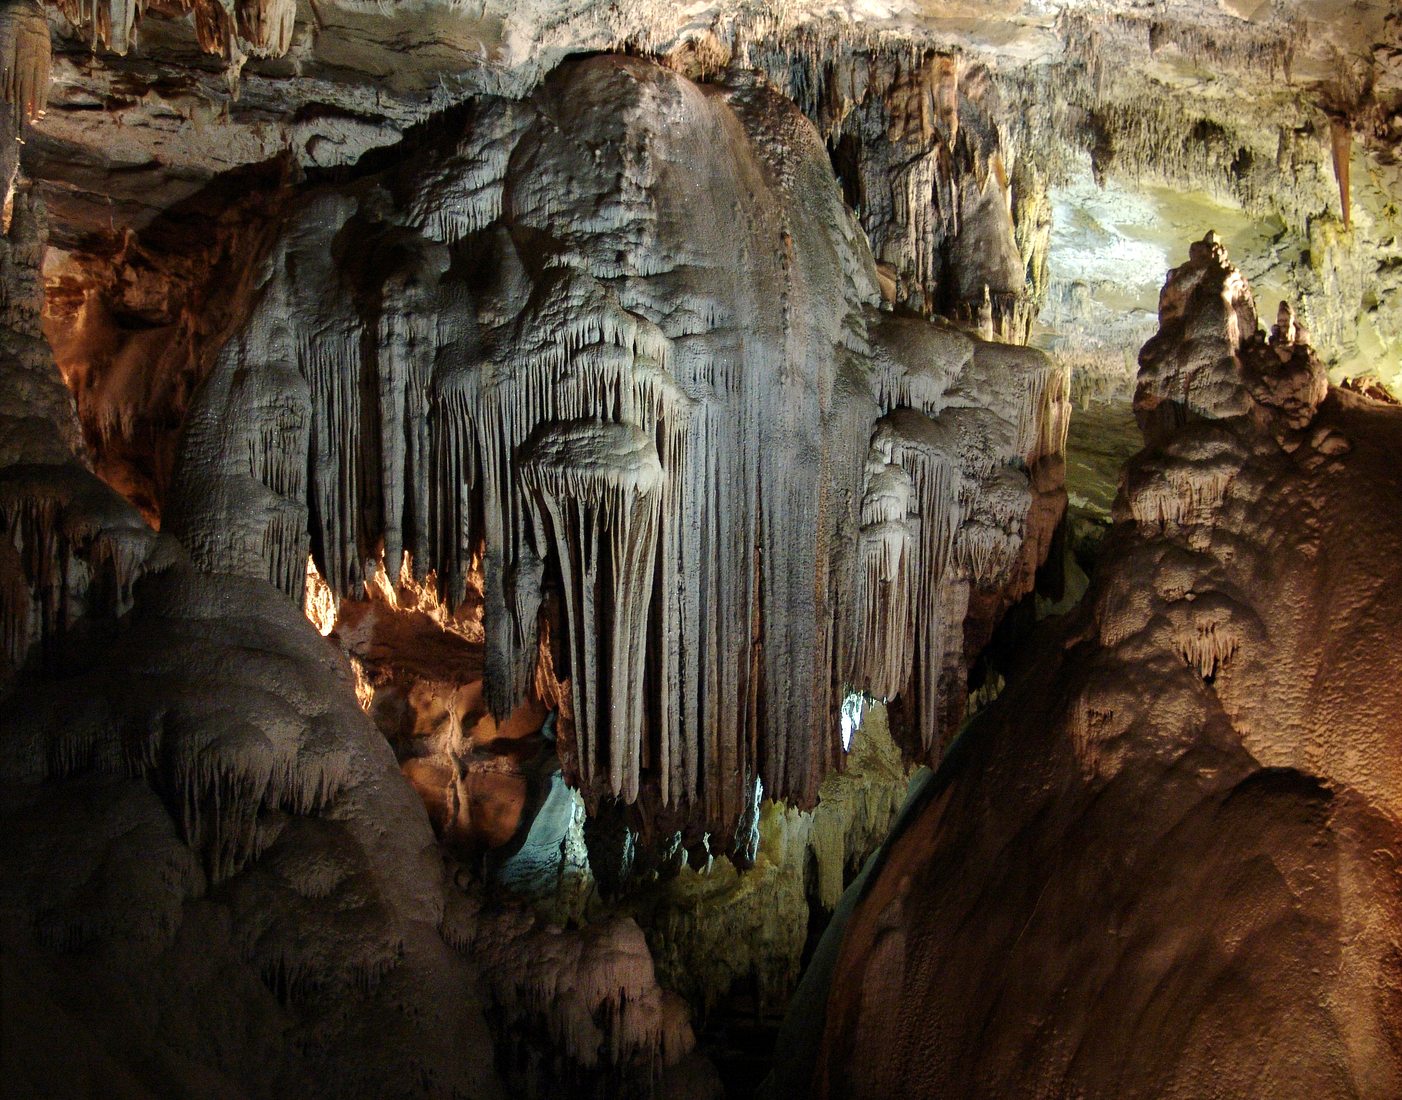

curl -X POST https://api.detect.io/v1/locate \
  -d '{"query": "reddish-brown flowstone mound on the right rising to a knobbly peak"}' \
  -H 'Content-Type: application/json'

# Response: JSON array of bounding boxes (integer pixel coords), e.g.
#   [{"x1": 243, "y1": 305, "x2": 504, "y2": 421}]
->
[{"x1": 813, "y1": 237, "x2": 1402, "y2": 1097}]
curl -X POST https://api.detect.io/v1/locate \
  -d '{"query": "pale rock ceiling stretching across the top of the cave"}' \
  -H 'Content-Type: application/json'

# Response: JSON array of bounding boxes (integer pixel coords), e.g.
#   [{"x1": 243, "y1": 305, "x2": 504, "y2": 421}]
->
[{"x1": 27, "y1": 0, "x2": 1402, "y2": 235}]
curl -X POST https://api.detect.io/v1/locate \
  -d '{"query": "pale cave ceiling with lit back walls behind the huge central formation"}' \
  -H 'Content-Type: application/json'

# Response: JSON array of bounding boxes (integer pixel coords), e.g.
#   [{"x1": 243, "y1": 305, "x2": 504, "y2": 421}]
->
[{"x1": 22, "y1": 0, "x2": 1402, "y2": 514}]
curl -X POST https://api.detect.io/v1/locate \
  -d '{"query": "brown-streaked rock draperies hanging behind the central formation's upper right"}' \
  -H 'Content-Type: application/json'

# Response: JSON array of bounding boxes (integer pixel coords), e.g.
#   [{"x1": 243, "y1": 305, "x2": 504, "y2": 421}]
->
[{"x1": 750, "y1": 34, "x2": 1046, "y2": 343}]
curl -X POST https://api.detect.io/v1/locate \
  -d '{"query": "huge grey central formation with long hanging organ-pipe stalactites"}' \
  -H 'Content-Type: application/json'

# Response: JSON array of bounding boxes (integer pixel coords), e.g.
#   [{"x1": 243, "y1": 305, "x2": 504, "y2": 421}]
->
[{"x1": 167, "y1": 57, "x2": 1067, "y2": 835}]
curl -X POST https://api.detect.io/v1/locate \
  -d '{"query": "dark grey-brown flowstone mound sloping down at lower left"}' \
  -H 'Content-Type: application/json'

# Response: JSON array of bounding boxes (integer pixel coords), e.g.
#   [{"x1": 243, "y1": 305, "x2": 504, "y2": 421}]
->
[{"x1": 0, "y1": 189, "x2": 496, "y2": 1096}]
